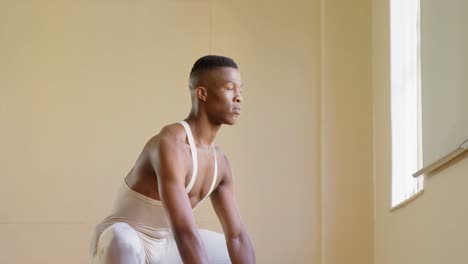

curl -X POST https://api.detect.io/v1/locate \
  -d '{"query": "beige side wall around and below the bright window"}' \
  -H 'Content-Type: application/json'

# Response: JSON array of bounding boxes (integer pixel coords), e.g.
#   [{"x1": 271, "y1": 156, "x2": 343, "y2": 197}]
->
[{"x1": 372, "y1": 0, "x2": 468, "y2": 264}]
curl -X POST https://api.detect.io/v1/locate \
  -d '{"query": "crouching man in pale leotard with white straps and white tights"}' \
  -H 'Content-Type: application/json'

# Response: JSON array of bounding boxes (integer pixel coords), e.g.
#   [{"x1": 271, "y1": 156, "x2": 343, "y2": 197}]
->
[{"x1": 91, "y1": 56, "x2": 255, "y2": 264}]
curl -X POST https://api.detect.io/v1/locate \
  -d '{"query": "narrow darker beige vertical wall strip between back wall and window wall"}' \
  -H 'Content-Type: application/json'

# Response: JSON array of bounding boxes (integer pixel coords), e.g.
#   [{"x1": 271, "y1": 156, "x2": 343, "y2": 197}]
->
[{"x1": 322, "y1": 0, "x2": 373, "y2": 264}]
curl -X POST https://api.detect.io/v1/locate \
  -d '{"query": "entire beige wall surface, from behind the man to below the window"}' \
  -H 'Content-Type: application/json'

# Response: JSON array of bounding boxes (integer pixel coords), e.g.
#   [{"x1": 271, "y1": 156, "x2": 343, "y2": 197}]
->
[{"x1": 0, "y1": 0, "x2": 458, "y2": 264}]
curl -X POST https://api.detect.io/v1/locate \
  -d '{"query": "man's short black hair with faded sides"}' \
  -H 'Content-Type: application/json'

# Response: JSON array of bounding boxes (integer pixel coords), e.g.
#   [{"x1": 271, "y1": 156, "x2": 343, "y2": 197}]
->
[{"x1": 190, "y1": 55, "x2": 238, "y2": 88}]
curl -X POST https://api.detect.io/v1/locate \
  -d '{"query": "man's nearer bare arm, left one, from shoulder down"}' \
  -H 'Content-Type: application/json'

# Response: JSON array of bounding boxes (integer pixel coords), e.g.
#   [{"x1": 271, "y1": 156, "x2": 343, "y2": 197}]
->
[{"x1": 152, "y1": 136, "x2": 208, "y2": 264}]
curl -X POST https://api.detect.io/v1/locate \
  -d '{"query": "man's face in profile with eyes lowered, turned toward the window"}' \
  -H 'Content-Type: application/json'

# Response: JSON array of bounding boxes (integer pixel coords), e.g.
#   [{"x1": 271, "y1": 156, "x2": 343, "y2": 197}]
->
[{"x1": 204, "y1": 67, "x2": 243, "y2": 125}]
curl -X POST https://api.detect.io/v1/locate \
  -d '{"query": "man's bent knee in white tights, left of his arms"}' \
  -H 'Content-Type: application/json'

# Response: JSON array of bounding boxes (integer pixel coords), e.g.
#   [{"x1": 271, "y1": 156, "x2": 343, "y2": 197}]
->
[{"x1": 100, "y1": 223, "x2": 141, "y2": 254}]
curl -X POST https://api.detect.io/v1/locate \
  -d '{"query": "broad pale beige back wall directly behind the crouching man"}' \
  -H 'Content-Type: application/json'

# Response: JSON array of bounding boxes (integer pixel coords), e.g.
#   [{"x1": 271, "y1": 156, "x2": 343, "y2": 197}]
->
[{"x1": 0, "y1": 0, "x2": 324, "y2": 264}]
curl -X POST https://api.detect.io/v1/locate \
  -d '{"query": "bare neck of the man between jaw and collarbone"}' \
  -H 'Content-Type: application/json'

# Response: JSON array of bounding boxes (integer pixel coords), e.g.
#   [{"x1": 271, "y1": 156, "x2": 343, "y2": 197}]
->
[{"x1": 185, "y1": 113, "x2": 221, "y2": 150}]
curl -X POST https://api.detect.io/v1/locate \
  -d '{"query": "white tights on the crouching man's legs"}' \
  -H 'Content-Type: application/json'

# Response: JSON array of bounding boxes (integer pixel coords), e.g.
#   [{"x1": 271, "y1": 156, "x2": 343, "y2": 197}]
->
[{"x1": 91, "y1": 222, "x2": 231, "y2": 264}]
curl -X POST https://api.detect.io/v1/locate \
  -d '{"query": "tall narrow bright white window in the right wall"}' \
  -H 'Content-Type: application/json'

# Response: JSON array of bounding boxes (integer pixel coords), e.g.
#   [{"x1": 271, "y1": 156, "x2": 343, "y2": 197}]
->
[{"x1": 390, "y1": 0, "x2": 423, "y2": 207}]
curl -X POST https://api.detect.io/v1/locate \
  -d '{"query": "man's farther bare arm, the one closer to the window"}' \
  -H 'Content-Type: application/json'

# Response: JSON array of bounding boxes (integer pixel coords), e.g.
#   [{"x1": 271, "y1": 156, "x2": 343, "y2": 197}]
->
[{"x1": 211, "y1": 153, "x2": 255, "y2": 264}]
